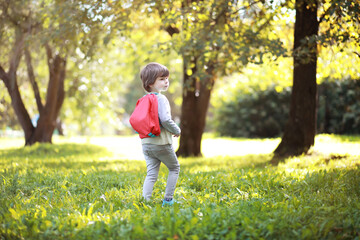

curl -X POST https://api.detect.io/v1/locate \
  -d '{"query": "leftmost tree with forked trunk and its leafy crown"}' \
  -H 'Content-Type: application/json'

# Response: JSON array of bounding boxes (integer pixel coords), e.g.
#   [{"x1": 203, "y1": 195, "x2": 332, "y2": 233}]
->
[{"x1": 0, "y1": 0, "x2": 129, "y2": 144}]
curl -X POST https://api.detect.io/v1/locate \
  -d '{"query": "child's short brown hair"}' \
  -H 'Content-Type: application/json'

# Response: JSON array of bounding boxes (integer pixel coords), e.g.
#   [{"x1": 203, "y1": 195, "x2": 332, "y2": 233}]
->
[{"x1": 140, "y1": 62, "x2": 170, "y2": 92}]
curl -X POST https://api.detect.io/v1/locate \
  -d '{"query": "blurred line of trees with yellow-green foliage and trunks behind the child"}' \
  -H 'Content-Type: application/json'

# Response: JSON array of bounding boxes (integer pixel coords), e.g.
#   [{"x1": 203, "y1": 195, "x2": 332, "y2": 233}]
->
[{"x1": 0, "y1": 0, "x2": 359, "y2": 159}]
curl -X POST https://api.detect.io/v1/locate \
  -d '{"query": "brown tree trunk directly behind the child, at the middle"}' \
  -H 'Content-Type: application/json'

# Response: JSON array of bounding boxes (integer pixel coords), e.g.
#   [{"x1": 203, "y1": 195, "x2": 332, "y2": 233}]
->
[{"x1": 177, "y1": 61, "x2": 214, "y2": 157}]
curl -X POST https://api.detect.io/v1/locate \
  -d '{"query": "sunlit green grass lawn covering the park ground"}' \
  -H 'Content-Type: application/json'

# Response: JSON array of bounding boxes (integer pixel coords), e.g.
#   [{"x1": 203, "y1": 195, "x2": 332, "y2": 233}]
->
[{"x1": 0, "y1": 135, "x2": 360, "y2": 239}]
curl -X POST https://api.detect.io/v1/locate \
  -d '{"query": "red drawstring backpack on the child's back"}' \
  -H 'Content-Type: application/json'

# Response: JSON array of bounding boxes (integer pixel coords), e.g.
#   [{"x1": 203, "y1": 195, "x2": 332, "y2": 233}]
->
[{"x1": 129, "y1": 93, "x2": 160, "y2": 138}]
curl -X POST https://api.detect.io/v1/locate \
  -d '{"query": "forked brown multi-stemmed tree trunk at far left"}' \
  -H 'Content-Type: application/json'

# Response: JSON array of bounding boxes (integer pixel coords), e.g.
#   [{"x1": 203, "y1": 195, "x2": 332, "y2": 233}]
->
[{"x1": 0, "y1": 26, "x2": 66, "y2": 145}]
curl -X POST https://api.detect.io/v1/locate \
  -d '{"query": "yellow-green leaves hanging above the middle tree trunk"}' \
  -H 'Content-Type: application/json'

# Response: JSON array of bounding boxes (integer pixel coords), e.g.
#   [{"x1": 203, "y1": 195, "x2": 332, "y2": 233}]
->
[{"x1": 144, "y1": 0, "x2": 285, "y2": 81}]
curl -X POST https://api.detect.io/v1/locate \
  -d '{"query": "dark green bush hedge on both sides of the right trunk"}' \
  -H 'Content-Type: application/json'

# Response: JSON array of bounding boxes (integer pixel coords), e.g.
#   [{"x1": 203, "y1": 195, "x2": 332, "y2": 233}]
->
[{"x1": 214, "y1": 79, "x2": 360, "y2": 138}]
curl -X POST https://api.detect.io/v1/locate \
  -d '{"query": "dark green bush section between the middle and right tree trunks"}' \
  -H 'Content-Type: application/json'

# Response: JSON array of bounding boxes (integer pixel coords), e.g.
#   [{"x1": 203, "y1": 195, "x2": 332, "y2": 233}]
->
[{"x1": 216, "y1": 88, "x2": 291, "y2": 138}]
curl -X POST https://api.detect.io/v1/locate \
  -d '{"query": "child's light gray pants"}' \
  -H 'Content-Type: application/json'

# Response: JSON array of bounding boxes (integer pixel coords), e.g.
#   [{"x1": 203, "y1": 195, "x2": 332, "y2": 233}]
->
[{"x1": 142, "y1": 144, "x2": 180, "y2": 200}]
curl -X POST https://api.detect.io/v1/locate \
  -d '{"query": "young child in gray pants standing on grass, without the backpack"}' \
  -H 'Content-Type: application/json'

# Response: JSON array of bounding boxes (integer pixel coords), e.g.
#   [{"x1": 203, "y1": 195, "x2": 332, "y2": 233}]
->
[{"x1": 140, "y1": 63, "x2": 181, "y2": 206}]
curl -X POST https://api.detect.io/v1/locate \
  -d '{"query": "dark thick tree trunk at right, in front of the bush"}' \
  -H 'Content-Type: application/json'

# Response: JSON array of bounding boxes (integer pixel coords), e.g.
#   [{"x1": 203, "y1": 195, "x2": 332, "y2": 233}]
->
[{"x1": 274, "y1": 0, "x2": 319, "y2": 158}]
